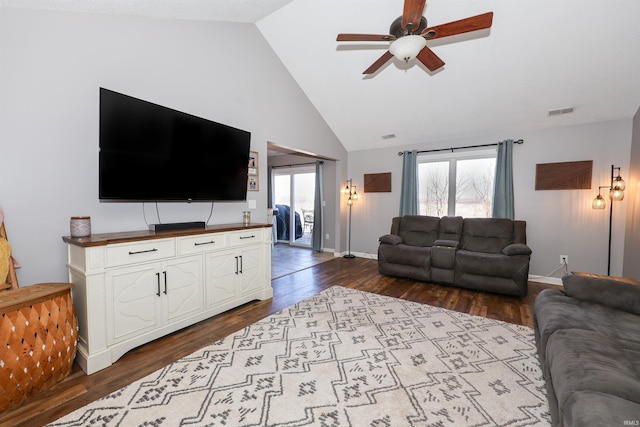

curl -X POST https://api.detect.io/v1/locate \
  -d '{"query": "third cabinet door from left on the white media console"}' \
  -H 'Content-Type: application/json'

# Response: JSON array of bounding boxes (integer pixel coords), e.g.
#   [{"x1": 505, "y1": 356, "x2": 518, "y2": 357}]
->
[{"x1": 205, "y1": 251, "x2": 240, "y2": 308}]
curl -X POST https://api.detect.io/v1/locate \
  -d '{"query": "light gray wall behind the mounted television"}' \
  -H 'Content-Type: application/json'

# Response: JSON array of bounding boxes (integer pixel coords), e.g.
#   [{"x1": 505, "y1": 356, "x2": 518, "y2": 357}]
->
[{"x1": 0, "y1": 8, "x2": 347, "y2": 285}]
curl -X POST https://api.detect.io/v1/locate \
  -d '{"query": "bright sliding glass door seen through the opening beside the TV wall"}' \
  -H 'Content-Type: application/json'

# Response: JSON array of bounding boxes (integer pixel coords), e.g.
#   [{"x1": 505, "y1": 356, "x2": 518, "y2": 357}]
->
[{"x1": 273, "y1": 166, "x2": 316, "y2": 248}]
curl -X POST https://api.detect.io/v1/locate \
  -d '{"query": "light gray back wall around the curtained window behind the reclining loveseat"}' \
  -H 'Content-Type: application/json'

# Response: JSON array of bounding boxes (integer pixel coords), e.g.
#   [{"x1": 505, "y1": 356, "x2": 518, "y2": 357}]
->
[{"x1": 348, "y1": 120, "x2": 632, "y2": 277}]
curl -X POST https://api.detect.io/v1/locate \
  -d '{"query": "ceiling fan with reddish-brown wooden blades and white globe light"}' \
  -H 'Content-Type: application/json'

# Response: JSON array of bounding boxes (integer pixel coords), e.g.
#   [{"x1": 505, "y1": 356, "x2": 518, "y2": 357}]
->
[{"x1": 337, "y1": 0, "x2": 493, "y2": 74}]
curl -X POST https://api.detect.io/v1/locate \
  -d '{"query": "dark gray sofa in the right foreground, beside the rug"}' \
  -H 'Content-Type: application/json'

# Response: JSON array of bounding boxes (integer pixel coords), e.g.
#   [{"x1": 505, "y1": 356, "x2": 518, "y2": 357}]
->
[{"x1": 534, "y1": 273, "x2": 640, "y2": 427}]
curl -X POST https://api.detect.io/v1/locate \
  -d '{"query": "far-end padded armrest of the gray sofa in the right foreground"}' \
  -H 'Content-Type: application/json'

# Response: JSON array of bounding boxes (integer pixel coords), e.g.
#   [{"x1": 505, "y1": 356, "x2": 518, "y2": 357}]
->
[{"x1": 562, "y1": 273, "x2": 640, "y2": 314}]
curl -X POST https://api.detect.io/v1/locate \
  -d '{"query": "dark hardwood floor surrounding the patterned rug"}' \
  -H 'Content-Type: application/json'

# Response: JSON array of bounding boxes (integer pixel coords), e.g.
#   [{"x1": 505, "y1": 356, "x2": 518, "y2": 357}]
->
[{"x1": 0, "y1": 258, "x2": 552, "y2": 427}]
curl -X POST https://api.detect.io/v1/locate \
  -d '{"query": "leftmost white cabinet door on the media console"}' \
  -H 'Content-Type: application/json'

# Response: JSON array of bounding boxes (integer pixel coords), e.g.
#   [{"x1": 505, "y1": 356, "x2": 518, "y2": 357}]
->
[{"x1": 105, "y1": 263, "x2": 162, "y2": 344}]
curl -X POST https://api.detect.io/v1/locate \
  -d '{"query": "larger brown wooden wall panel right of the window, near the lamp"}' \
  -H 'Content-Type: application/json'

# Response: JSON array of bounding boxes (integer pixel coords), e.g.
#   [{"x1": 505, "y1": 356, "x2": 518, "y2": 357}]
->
[{"x1": 536, "y1": 160, "x2": 593, "y2": 190}]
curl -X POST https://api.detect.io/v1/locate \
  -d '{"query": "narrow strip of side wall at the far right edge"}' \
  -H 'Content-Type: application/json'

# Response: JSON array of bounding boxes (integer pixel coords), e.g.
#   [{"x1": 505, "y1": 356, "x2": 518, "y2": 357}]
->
[{"x1": 623, "y1": 108, "x2": 640, "y2": 280}]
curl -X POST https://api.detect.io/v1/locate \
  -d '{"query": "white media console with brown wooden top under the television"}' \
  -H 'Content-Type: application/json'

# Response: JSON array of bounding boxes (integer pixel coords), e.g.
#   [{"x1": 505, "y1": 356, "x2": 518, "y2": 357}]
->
[{"x1": 63, "y1": 224, "x2": 273, "y2": 374}]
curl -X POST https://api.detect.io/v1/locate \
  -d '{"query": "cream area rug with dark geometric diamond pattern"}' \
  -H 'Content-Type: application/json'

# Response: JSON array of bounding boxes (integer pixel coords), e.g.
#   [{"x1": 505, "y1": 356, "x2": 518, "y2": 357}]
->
[{"x1": 51, "y1": 286, "x2": 550, "y2": 427}]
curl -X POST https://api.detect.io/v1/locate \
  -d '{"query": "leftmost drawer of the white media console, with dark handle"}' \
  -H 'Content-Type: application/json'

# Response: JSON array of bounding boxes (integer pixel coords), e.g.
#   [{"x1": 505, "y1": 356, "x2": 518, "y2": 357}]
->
[{"x1": 107, "y1": 239, "x2": 176, "y2": 267}]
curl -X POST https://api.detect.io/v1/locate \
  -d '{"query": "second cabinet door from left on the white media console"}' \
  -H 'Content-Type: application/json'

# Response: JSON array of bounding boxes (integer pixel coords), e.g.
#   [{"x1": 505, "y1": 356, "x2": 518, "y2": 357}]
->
[{"x1": 162, "y1": 256, "x2": 204, "y2": 323}]
